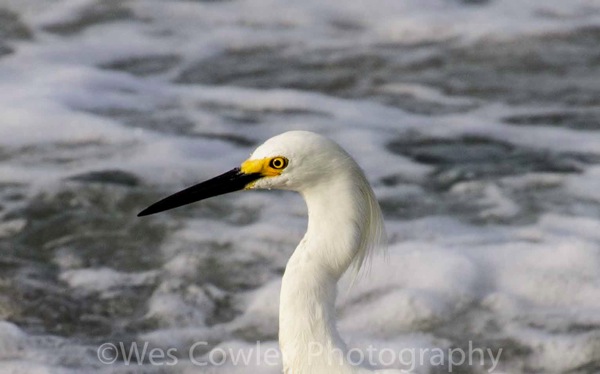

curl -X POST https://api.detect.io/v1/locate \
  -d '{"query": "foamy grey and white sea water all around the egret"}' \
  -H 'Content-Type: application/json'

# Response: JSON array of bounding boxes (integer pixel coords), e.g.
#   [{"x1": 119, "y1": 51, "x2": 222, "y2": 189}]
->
[{"x1": 0, "y1": 0, "x2": 600, "y2": 373}]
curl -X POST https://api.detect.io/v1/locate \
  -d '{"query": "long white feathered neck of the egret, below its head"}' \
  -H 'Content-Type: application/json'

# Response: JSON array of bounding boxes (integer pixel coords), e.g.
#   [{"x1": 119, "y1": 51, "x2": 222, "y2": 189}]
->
[{"x1": 279, "y1": 171, "x2": 385, "y2": 374}]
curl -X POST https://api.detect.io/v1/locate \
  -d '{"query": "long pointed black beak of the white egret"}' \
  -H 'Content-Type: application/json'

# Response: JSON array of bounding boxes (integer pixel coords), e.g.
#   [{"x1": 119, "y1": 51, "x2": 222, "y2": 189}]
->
[{"x1": 138, "y1": 168, "x2": 262, "y2": 217}]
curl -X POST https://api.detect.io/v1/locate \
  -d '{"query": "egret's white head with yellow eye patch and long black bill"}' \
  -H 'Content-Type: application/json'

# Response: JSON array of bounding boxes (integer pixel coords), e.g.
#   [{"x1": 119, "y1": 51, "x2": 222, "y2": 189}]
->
[{"x1": 138, "y1": 131, "x2": 358, "y2": 216}]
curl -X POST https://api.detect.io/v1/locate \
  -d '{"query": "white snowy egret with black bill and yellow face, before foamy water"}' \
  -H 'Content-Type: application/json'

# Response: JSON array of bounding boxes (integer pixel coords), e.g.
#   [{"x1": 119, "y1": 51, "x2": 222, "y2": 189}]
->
[{"x1": 139, "y1": 131, "x2": 397, "y2": 374}]
